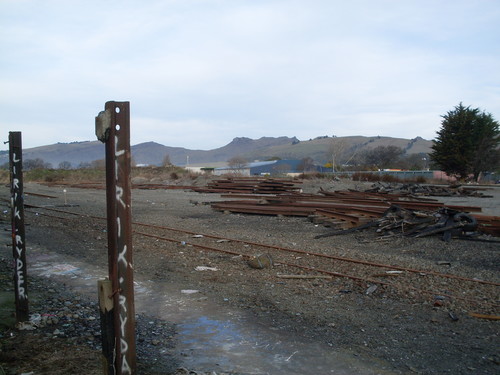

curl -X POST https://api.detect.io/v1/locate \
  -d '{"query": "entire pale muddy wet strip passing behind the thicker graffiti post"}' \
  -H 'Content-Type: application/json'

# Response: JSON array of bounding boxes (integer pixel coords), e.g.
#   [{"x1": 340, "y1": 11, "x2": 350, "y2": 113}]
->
[{"x1": 29, "y1": 249, "x2": 392, "y2": 375}]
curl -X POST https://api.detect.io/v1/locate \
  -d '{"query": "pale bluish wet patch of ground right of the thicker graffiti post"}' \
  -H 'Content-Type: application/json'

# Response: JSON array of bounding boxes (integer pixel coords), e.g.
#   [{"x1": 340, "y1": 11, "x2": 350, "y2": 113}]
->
[{"x1": 135, "y1": 281, "x2": 391, "y2": 375}]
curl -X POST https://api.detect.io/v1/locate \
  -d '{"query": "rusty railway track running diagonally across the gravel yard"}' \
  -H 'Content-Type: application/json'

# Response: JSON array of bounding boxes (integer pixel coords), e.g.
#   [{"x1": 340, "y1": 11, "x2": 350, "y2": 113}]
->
[{"x1": 20, "y1": 205, "x2": 500, "y2": 316}]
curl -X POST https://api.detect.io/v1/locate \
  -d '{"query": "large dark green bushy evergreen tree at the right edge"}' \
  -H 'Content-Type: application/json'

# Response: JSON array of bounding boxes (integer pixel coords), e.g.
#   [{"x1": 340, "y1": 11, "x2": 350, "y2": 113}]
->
[{"x1": 430, "y1": 103, "x2": 500, "y2": 180}]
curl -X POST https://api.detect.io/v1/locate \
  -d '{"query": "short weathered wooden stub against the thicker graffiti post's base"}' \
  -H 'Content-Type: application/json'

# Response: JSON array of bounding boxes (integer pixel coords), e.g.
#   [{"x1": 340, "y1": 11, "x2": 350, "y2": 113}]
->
[{"x1": 97, "y1": 279, "x2": 115, "y2": 375}]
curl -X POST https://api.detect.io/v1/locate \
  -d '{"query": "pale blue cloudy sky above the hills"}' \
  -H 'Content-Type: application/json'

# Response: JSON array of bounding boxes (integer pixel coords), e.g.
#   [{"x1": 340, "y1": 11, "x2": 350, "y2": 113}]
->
[{"x1": 0, "y1": 0, "x2": 500, "y2": 150}]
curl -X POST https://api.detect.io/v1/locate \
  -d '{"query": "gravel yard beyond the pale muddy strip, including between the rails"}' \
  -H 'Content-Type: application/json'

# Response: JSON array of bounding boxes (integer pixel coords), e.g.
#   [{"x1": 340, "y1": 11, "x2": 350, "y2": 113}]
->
[{"x1": 1, "y1": 181, "x2": 500, "y2": 374}]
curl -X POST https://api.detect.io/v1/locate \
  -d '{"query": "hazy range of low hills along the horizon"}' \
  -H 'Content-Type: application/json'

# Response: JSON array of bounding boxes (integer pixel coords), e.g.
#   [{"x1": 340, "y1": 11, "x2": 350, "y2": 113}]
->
[{"x1": 0, "y1": 136, "x2": 432, "y2": 168}]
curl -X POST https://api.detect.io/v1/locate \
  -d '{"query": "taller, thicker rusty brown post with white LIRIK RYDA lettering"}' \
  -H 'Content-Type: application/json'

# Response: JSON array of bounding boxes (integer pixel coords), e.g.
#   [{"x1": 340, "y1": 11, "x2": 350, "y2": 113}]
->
[{"x1": 96, "y1": 101, "x2": 136, "y2": 375}]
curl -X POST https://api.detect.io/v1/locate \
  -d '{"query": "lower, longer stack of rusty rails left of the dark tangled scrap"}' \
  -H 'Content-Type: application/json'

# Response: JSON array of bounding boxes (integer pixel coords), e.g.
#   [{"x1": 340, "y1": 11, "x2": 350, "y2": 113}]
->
[{"x1": 212, "y1": 190, "x2": 500, "y2": 236}]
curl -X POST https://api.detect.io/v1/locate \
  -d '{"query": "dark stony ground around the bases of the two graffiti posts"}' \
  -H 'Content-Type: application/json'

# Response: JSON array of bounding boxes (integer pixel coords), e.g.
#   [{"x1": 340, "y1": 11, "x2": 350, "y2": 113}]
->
[{"x1": 0, "y1": 257, "x2": 177, "y2": 375}]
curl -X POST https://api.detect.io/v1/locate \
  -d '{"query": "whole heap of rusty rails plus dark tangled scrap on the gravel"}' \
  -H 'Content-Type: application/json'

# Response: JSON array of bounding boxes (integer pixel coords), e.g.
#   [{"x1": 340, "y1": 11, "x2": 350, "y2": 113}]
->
[{"x1": 203, "y1": 179, "x2": 500, "y2": 241}]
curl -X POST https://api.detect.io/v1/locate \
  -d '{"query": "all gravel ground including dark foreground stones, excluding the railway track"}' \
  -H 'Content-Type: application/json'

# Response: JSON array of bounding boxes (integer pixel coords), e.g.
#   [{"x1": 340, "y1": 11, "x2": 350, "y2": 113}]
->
[{"x1": 0, "y1": 181, "x2": 500, "y2": 374}]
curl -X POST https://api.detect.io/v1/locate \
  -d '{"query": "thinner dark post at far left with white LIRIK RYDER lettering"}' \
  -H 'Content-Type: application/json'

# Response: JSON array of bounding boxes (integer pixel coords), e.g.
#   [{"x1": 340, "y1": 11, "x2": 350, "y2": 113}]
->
[{"x1": 9, "y1": 132, "x2": 29, "y2": 323}]
